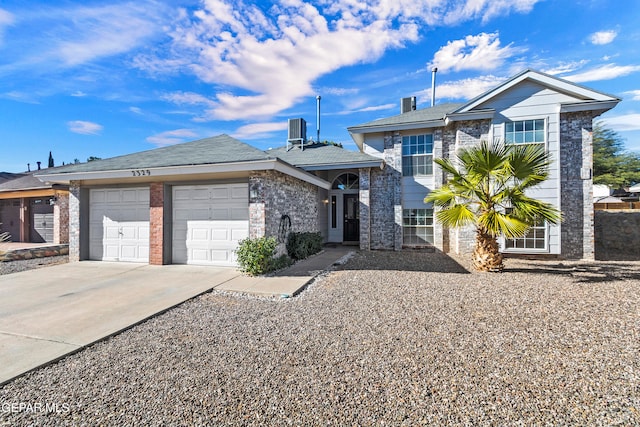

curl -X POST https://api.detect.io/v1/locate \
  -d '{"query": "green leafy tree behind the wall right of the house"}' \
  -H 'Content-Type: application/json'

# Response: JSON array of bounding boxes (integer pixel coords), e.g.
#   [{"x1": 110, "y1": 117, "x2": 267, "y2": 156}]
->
[{"x1": 593, "y1": 122, "x2": 640, "y2": 189}]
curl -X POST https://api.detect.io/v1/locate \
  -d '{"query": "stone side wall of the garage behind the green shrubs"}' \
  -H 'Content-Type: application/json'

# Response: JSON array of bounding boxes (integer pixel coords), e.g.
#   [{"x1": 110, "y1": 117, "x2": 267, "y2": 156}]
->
[{"x1": 249, "y1": 171, "x2": 320, "y2": 249}]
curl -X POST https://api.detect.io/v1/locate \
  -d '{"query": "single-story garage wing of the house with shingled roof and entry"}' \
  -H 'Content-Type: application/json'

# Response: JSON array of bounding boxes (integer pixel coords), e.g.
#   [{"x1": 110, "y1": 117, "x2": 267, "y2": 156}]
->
[{"x1": 40, "y1": 135, "x2": 383, "y2": 266}]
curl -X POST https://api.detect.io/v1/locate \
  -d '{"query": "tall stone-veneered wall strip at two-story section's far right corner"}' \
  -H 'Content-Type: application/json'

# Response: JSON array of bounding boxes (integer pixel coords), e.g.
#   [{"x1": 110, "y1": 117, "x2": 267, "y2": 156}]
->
[{"x1": 560, "y1": 112, "x2": 595, "y2": 259}]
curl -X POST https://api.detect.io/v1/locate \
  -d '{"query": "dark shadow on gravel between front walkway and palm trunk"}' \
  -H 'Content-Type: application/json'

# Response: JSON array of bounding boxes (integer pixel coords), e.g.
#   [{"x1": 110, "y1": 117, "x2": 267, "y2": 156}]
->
[{"x1": 340, "y1": 251, "x2": 471, "y2": 274}]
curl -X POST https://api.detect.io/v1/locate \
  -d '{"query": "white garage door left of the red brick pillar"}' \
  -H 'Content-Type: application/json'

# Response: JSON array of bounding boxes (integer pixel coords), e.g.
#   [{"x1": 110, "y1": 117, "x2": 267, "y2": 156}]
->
[{"x1": 89, "y1": 188, "x2": 149, "y2": 262}]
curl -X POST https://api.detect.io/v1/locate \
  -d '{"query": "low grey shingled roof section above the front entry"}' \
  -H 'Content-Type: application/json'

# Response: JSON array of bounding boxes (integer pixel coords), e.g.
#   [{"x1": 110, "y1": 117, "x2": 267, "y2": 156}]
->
[{"x1": 265, "y1": 143, "x2": 384, "y2": 171}]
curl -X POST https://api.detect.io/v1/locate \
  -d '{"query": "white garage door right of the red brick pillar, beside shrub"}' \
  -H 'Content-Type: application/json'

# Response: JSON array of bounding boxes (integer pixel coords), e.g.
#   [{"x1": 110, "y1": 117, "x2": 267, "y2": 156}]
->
[{"x1": 172, "y1": 183, "x2": 249, "y2": 266}]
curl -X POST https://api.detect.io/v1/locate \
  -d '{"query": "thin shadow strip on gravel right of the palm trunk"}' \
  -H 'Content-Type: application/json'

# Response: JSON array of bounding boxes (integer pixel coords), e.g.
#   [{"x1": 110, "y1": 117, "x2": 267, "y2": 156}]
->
[{"x1": 505, "y1": 261, "x2": 640, "y2": 283}]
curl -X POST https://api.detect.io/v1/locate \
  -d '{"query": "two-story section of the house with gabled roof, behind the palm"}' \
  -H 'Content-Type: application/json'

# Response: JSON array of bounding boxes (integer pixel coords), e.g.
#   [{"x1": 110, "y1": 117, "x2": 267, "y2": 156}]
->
[{"x1": 348, "y1": 70, "x2": 620, "y2": 259}]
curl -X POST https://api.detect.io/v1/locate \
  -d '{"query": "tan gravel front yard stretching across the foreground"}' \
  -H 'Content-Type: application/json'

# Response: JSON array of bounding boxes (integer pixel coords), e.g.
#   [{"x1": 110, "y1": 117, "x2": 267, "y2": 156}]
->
[{"x1": 0, "y1": 252, "x2": 640, "y2": 426}]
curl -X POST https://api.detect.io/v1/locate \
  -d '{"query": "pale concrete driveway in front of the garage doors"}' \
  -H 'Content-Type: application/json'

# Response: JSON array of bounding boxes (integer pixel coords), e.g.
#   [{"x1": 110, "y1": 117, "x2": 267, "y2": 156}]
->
[{"x1": 0, "y1": 261, "x2": 239, "y2": 384}]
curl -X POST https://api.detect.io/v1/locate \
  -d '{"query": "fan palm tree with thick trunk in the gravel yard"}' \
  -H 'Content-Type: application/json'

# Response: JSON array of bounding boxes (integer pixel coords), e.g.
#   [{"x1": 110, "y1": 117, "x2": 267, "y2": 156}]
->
[{"x1": 424, "y1": 142, "x2": 561, "y2": 272}]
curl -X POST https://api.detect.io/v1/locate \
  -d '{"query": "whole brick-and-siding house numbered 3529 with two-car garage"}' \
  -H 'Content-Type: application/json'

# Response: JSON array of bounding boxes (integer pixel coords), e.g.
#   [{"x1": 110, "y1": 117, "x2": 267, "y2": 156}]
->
[{"x1": 38, "y1": 70, "x2": 619, "y2": 265}]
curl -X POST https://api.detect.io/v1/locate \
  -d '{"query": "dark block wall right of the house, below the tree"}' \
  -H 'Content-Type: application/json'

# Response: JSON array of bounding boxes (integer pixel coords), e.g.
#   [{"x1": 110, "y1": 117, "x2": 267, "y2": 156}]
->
[{"x1": 594, "y1": 210, "x2": 640, "y2": 261}]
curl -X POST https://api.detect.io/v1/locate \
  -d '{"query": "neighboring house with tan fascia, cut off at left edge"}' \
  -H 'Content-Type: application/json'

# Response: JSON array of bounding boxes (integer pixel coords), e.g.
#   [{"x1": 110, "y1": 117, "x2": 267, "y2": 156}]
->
[{"x1": 0, "y1": 171, "x2": 69, "y2": 244}]
